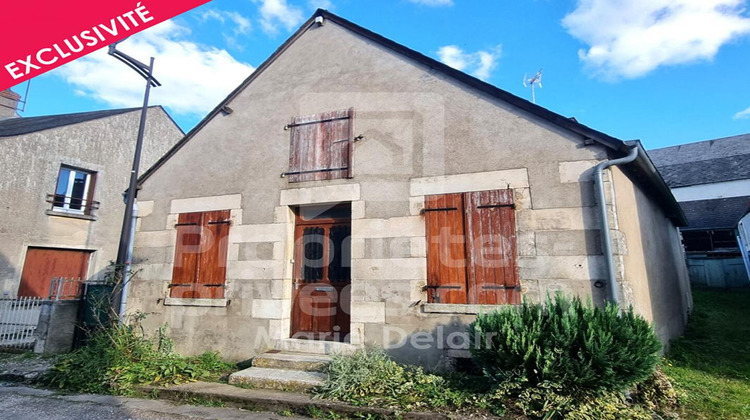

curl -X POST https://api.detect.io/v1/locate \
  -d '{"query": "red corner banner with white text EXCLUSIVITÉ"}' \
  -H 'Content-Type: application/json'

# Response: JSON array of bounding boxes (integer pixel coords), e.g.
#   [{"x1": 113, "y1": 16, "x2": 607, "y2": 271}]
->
[{"x1": 0, "y1": 0, "x2": 210, "y2": 90}]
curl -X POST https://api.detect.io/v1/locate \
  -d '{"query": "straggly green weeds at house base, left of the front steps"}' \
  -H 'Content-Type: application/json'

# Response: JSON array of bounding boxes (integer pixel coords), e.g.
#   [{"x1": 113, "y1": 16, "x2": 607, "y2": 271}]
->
[{"x1": 44, "y1": 325, "x2": 233, "y2": 395}]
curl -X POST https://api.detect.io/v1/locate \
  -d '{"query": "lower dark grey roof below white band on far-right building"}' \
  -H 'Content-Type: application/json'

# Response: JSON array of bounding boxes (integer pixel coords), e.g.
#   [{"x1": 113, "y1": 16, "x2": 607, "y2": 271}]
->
[{"x1": 680, "y1": 196, "x2": 750, "y2": 229}]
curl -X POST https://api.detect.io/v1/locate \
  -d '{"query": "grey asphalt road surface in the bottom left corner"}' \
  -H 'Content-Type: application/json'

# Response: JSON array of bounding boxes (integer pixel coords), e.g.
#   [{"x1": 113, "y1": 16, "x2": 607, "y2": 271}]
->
[{"x1": 0, "y1": 383, "x2": 309, "y2": 420}]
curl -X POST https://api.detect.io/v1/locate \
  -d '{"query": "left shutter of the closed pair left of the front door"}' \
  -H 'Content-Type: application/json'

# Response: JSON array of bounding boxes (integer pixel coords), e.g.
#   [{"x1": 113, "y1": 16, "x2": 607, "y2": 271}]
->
[{"x1": 169, "y1": 213, "x2": 202, "y2": 298}]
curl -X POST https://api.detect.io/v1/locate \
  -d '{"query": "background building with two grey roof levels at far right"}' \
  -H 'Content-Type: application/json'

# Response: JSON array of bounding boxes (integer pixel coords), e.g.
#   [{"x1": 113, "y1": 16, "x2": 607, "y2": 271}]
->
[{"x1": 648, "y1": 134, "x2": 750, "y2": 287}]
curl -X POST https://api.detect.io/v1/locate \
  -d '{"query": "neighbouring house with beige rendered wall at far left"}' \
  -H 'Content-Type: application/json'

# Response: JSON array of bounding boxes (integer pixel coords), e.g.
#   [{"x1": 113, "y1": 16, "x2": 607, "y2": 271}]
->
[{"x1": 0, "y1": 90, "x2": 183, "y2": 298}]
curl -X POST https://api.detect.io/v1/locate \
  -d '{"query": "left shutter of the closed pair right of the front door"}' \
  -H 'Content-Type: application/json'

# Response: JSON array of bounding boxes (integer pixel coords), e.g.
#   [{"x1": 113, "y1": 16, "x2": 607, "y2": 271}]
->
[{"x1": 425, "y1": 194, "x2": 466, "y2": 303}]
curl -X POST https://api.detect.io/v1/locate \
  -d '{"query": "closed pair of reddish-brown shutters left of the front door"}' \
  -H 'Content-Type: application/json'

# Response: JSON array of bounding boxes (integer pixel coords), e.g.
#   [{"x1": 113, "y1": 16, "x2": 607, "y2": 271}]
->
[{"x1": 169, "y1": 210, "x2": 231, "y2": 299}]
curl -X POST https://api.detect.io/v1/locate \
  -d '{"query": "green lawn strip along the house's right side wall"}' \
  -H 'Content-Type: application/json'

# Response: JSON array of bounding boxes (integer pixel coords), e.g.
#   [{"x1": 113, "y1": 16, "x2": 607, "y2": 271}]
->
[{"x1": 664, "y1": 289, "x2": 750, "y2": 419}]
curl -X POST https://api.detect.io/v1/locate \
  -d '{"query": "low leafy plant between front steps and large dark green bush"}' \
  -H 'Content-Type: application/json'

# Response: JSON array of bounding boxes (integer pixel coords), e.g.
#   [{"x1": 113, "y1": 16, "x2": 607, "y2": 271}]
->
[{"x1": 315, "y1": 349, "x2": 500, "y2": 410}]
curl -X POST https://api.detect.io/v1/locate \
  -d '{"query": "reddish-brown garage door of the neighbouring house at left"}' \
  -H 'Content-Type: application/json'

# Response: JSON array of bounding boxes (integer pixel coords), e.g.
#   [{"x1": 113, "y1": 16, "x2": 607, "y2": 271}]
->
[{"x1": 18, "y1": 248, "x2": 91, "y2": 298}]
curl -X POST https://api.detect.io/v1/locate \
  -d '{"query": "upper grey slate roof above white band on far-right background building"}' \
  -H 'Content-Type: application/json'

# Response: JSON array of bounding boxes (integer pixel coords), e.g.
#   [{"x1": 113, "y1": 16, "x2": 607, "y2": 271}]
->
[{"x1": 648, "y1": 134, "x2": 750, "y2": 188}]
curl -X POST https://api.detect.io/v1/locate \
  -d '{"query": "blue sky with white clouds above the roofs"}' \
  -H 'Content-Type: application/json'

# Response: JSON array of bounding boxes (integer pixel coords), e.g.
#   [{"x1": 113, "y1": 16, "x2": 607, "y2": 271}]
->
[{"x1": 14, "y1": 0, "x2": 750, "y2": 148}]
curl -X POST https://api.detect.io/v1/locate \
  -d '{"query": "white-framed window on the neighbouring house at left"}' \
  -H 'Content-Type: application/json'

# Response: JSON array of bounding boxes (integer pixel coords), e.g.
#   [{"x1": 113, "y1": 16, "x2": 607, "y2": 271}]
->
[{"x1": 52, "y1": 166, "x2": 96, "y2": 214}]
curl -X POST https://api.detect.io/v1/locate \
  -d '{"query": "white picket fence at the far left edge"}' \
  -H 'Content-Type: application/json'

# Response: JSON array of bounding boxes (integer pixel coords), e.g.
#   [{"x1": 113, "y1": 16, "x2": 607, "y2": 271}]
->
[{"x1": 0, "y1": 297, "x2": 44, "y2": 349}]
